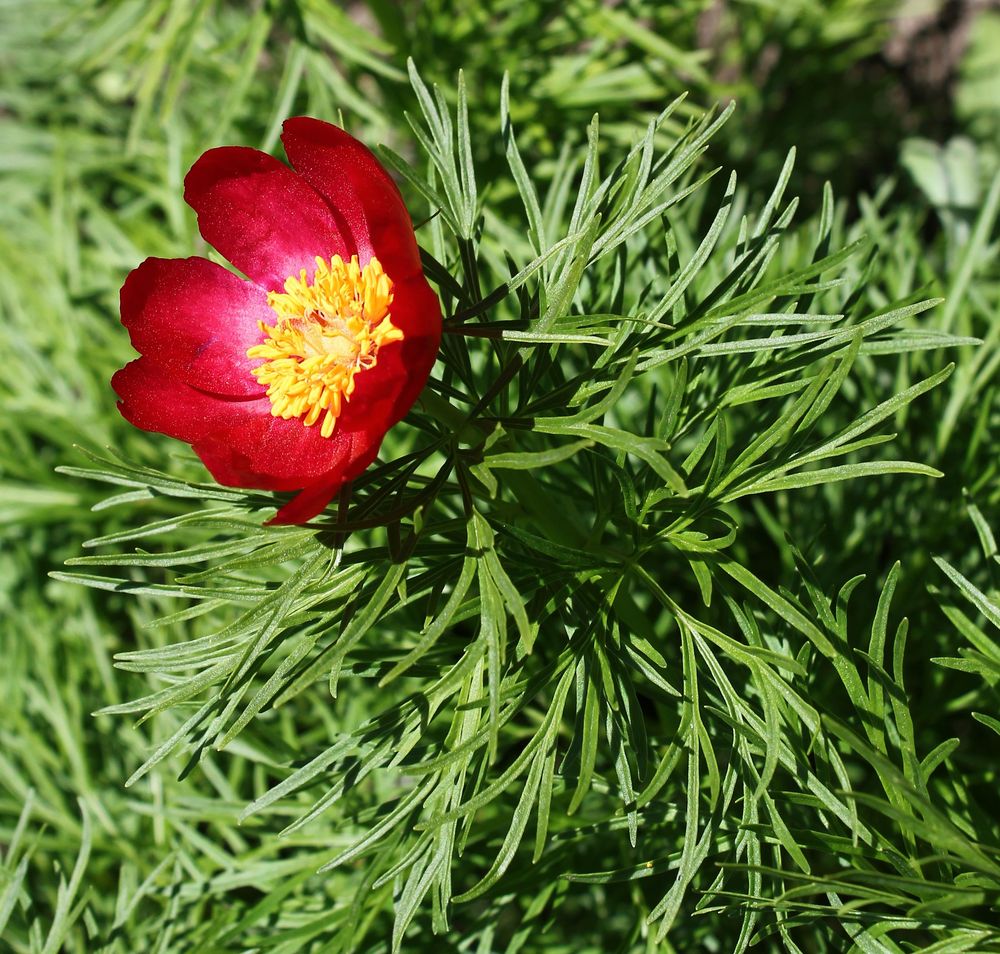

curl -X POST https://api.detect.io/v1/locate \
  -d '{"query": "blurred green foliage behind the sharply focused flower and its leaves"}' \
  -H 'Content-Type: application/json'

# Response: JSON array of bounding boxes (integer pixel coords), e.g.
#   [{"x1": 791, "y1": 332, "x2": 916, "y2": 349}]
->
[{"x1": 0, "y1": 0, "x2": 1000, "y2": 952}]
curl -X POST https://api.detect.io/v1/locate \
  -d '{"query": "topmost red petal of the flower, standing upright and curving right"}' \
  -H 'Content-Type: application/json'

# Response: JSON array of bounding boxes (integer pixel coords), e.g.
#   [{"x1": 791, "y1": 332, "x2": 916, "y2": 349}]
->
[{"x1": 281, "y1": 116, "x2": 421, "y2": 282}]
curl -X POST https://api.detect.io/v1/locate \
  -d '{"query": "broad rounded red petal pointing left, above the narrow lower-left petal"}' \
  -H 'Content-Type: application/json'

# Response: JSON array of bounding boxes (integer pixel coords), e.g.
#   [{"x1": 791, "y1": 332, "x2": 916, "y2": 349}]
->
[{"x1": 121, "y1": 258, "x2": 274, "y2": 397}]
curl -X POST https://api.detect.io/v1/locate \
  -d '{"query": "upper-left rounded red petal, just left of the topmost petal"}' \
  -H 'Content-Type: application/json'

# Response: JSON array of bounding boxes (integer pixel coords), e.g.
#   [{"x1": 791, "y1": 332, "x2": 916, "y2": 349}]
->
[{"x1": 184, "y1": 146, "x2": 352, "y2": 291}]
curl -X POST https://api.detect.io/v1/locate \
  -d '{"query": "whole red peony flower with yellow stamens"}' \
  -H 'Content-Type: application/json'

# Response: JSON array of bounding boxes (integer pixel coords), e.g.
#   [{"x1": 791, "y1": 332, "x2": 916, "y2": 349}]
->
[{"x1": 111, "y1": 116, "x2": 441, "y2": 523}]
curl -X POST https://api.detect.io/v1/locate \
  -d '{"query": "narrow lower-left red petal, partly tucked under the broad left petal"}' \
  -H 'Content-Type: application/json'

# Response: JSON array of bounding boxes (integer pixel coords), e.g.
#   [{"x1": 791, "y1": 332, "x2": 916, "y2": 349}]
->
[{"x1": 111, "y1": 357, "x2": 260, "y2": 443}]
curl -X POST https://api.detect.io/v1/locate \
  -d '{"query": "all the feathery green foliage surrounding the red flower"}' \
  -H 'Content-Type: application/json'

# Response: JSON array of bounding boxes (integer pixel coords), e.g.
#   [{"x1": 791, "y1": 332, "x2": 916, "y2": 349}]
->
[{"x1": 0, "y1": 0, "x2": 1000, "y2": 952}]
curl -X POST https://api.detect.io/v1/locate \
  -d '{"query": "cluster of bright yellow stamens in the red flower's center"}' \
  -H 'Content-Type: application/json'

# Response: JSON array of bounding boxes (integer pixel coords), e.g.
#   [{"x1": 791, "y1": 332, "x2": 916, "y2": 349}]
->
[{"x1": 247, "y1": 255, "x2": 403, "y2": 437}]
